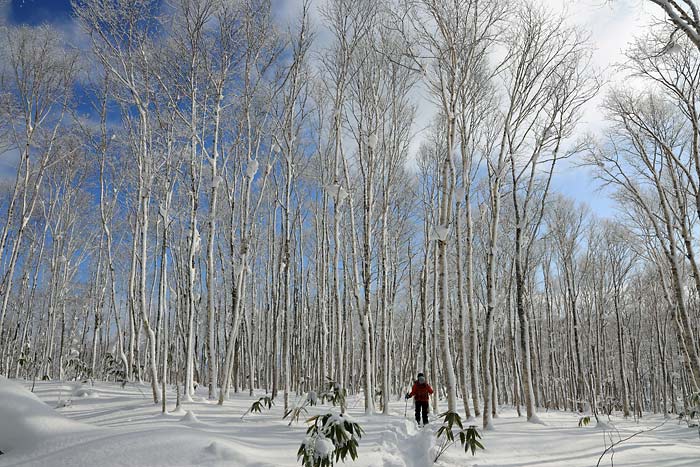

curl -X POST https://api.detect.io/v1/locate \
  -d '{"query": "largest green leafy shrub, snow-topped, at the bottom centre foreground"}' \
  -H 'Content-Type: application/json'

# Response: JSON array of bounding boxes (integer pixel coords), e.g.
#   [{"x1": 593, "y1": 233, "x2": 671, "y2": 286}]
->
[{"x1": 297, "y1": 412, "x2": 364, "y2": 467}]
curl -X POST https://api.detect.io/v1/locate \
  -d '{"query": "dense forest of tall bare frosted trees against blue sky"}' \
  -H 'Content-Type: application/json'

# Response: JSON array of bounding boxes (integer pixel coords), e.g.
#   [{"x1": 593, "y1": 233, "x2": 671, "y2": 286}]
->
[{"x1": 0, "y1": 0, "x2": 700, "y2": 436}]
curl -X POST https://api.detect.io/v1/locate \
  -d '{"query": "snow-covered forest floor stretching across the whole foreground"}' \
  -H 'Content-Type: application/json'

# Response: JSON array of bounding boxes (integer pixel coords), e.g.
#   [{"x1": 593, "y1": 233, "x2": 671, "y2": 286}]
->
[{"x1": 0, "y1": 377, "x2": 700, "y2": 467}]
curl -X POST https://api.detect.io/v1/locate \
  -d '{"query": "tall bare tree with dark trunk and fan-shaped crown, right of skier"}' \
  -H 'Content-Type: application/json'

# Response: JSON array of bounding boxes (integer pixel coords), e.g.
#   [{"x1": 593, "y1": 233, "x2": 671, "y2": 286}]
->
[{"x1": 508, "y1": 10, "x2": 597, "y2": 422}]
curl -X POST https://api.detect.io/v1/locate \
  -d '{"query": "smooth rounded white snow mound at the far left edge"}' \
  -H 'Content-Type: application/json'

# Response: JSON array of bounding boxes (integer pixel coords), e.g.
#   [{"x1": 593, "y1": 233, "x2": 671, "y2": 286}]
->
[{"x1": 0, "y1": 376, "x2": 94, "y2": 454}]
